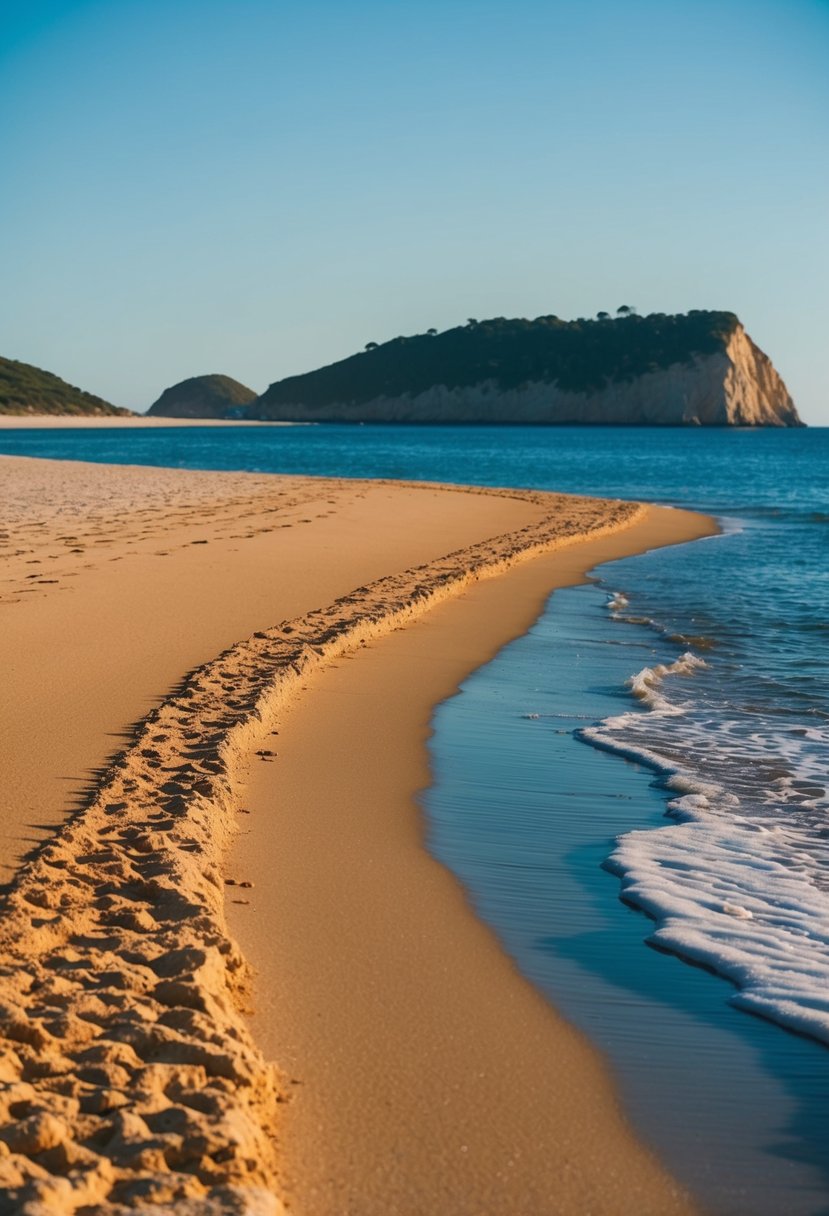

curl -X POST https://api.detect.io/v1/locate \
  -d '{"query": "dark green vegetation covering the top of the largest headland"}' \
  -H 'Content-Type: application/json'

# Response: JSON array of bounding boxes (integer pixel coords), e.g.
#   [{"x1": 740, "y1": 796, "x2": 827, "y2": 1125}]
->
[{"x1": 255, "y1": 309, "x2": 739, "y2": 417}]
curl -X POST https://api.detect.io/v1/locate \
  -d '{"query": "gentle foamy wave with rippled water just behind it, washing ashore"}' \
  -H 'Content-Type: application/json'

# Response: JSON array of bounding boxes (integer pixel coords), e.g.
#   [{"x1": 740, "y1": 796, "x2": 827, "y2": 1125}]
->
[{"x1": 576, "y1": 583, "x2": 829, "y2": 1043}]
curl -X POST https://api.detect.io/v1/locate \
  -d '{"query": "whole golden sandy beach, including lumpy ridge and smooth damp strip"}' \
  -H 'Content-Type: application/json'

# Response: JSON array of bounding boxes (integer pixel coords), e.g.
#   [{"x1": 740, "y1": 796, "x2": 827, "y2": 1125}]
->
[{"x1": 0, "y1": 457, "x2": 714, "y2": 1216}]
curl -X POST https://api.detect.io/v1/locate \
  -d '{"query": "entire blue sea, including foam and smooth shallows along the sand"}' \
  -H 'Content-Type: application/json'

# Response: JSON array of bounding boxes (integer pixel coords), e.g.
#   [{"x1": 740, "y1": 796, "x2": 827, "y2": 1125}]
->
[{"x1": 0, "y1": 424, "x2": 829, "y2": 1216}]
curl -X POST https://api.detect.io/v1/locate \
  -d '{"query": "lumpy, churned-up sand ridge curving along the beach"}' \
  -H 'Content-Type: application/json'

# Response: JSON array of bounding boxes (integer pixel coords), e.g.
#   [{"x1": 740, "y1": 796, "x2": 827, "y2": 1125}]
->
[{"x1": 0, "y1": 462, "x2": 705, "y2": 1212}]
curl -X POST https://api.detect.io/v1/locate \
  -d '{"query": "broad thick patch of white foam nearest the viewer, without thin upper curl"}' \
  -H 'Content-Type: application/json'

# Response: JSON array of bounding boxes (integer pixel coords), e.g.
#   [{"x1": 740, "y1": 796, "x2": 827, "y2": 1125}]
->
[{"x1": 607, "y1": 815, "x2": 829, "y2": 1043}]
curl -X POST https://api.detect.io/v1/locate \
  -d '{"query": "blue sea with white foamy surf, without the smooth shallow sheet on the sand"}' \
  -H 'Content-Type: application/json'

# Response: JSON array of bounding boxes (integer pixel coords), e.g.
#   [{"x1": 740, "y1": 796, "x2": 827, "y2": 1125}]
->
[{"x1": 0, "y1": 426, "x2": 829, "y2": 1026}]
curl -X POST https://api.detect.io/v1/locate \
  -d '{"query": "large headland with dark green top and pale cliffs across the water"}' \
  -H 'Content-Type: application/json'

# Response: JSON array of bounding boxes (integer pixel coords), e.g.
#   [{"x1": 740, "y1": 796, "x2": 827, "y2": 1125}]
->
[{"x1": 248, "y1": 313, "x2": 801, "y2": 427}]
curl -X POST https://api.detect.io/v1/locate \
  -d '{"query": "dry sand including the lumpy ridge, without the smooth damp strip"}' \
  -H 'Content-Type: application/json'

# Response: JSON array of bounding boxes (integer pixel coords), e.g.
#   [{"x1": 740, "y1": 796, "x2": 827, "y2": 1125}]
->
[{"x1": 0, "y1": 460, "x2": 709, "y2": 1216}]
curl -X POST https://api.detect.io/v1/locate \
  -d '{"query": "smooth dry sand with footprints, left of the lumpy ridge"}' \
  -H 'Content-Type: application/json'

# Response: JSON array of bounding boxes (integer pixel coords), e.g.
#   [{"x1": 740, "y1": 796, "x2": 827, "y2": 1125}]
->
[{"x1": 0, "y1": 460, "x2": 541, "y2": 880}]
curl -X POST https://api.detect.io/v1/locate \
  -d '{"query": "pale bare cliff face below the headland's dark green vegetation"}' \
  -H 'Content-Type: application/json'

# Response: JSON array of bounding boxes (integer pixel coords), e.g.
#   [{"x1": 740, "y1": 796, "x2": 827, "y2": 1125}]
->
[{"x1": 249, "y1": 325, "x2": 802, "y2": 427}]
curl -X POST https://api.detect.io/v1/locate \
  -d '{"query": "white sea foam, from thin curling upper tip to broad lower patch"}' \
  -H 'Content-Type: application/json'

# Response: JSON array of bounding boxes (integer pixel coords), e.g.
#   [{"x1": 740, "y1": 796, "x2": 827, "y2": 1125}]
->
[{"x1": 579, "y1": 652, "x2": 829, "y2": 1043}]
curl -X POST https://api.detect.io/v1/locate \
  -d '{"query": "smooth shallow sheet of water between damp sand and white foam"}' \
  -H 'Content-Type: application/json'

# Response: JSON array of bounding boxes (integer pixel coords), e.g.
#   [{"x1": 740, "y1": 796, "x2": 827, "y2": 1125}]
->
[{"x1": 423, "y1": 573, "x2": 829, "y2": 1216}]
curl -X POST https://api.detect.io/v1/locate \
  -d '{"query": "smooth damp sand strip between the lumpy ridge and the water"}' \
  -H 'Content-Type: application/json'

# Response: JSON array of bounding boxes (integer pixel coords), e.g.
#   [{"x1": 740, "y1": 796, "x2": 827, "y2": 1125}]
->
[{"x1": 229, "y1": 498, "x2": 712, "y2": 1216}]
